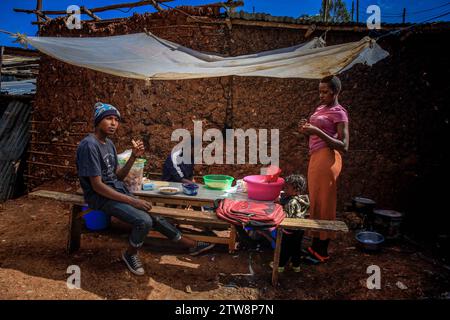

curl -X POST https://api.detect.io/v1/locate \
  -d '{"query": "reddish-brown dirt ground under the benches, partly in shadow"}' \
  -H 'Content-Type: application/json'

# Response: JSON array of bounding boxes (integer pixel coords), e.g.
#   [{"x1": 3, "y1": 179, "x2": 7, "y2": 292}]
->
[{"x1": 0, "y1": 182, "x2": 450, "y2": 300}]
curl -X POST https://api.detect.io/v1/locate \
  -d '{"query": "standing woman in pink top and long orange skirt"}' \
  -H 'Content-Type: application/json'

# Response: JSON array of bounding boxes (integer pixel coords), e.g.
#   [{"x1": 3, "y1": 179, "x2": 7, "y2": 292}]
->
[{"x1": 299, "y1": 76, "x2": 349, "y2": 262}]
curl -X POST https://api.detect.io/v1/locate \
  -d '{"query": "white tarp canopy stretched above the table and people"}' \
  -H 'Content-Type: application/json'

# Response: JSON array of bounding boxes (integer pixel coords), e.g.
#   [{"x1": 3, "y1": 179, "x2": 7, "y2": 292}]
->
[{"x1": 22, "y1": 33, "x2": 389, "y2": 80}]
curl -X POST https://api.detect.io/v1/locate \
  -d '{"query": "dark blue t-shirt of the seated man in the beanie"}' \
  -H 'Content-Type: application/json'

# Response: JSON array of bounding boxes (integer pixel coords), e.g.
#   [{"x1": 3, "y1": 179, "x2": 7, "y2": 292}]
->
[{"x1": 77, "y1": 134, "x2": 130, "y2": 210}]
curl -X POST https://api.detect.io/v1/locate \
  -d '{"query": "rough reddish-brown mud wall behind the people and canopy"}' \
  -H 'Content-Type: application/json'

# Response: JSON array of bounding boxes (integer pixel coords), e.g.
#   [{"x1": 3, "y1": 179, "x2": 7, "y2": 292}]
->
[{"x1": 30, "y1": 12, "x2": 450, "y2": 235}]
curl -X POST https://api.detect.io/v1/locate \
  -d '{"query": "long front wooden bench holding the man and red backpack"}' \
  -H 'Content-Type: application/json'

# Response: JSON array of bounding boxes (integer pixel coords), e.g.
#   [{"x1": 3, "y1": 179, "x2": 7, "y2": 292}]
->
[{"x1": 29, "y1": 190, "x2": 348, "y2": 285}]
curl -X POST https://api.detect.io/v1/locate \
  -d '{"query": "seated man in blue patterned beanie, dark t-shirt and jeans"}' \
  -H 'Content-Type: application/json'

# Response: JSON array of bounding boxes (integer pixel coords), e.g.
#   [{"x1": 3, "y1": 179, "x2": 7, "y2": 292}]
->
[{"x1": 77, "y1": 102, "x2": 214, "y2": 275}]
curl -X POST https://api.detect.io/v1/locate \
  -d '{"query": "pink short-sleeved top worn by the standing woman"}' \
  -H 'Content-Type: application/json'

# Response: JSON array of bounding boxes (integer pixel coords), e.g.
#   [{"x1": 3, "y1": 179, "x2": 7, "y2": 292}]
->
[{"x1": 309, "y1": 104, "x2": 348, "y2": 154}]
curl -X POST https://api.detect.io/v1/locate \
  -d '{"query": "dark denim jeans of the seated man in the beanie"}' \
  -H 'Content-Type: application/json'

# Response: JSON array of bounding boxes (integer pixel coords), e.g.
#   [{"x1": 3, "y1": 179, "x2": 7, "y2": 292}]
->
[{"x1": 100, "y1": 199, "x2": 181, "y2": 248}]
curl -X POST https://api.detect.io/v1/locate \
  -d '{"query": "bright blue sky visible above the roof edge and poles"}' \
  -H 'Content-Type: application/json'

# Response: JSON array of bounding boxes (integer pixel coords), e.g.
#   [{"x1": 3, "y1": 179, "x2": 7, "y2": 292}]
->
[{"x1": 0, "y1": 0, "x2": 450, "y2": 46}]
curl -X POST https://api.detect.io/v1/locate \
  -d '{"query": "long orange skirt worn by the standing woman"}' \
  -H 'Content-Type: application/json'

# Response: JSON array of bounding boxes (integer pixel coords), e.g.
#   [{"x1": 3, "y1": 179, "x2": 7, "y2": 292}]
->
[{"x1": 307, "y1": 148, "x2": 342, "y2": 240}]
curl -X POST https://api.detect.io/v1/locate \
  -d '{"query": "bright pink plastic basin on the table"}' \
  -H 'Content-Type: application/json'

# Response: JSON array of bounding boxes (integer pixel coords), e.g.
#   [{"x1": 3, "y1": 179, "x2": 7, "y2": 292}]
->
[{"x1": 244, "y1": 175, "x2": 284, "y2": 201}]
